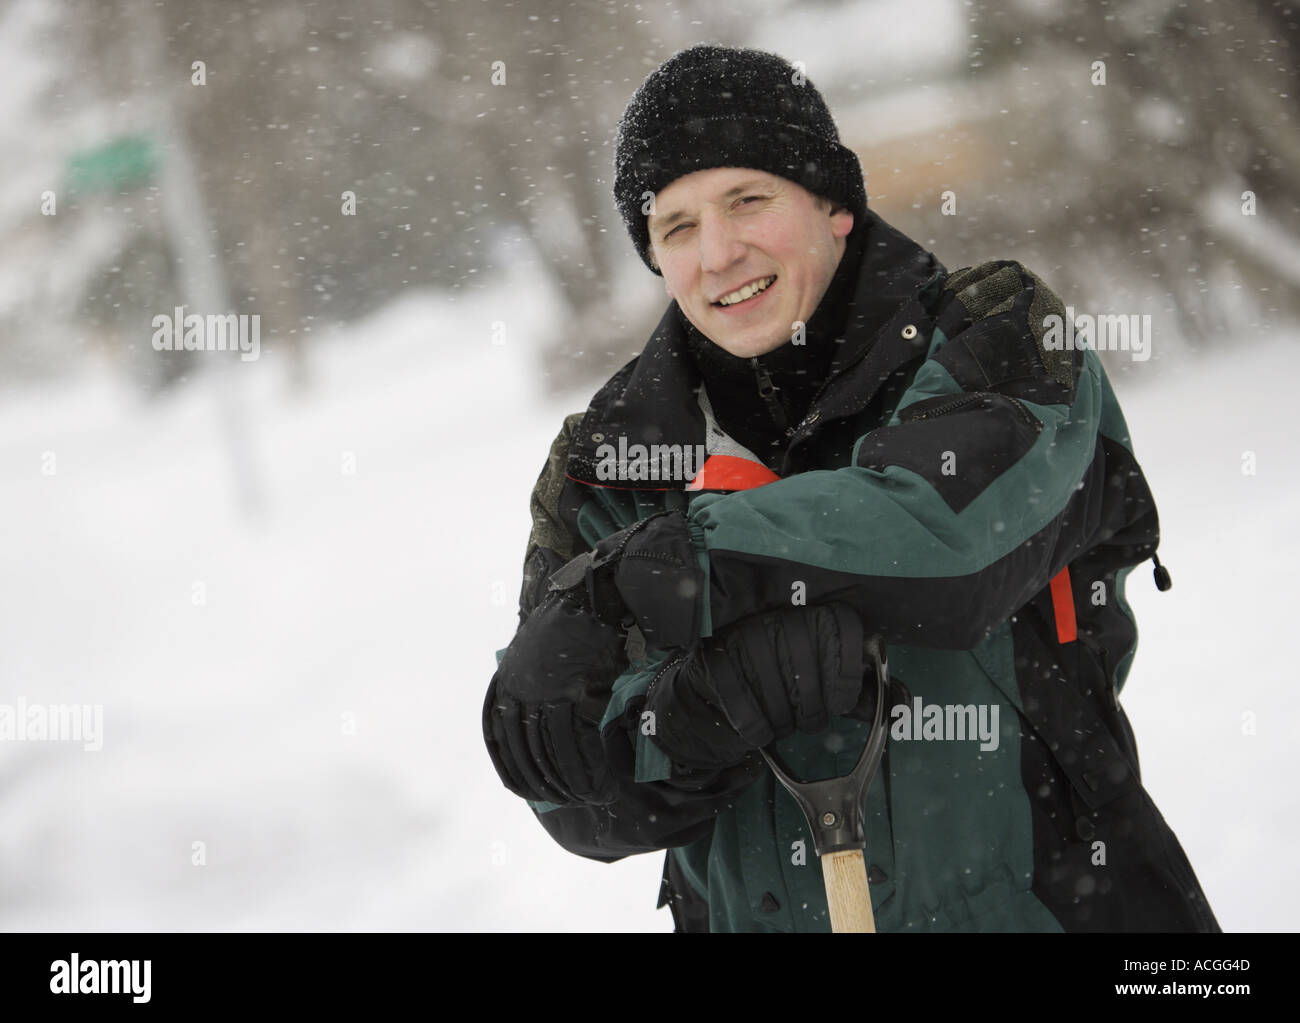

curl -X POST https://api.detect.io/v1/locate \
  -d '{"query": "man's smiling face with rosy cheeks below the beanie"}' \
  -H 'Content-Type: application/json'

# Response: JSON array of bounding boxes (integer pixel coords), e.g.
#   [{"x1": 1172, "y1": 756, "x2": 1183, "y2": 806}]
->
[{"x1": 647, "y1": 166, "x2": 853, "y2": 359}]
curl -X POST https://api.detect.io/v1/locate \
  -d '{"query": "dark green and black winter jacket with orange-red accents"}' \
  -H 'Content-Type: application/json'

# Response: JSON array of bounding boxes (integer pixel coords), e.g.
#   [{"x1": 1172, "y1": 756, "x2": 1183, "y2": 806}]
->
[{"x1": 504, "y1": 207, "x2": 1218, "y2": 932}]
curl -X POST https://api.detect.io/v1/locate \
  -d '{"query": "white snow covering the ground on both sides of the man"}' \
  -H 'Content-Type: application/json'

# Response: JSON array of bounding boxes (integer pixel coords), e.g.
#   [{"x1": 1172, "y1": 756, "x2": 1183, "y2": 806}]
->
[{"x1": 0, "y1": 266, "x2": 1300, "y2": 931}]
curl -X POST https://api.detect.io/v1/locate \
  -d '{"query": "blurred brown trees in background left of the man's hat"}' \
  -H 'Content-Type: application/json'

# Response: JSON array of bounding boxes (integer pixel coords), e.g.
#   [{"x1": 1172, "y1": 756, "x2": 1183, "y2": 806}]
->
[{"x1": 32, "y1": 0, "x2": 722, "y2": 387}]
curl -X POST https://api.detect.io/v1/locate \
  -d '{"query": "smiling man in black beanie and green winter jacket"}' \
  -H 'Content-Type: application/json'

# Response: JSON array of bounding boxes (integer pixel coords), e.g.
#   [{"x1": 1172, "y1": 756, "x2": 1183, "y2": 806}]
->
[{"x1": 484, "y1": 45, "x2": 1218, "y2": 932}]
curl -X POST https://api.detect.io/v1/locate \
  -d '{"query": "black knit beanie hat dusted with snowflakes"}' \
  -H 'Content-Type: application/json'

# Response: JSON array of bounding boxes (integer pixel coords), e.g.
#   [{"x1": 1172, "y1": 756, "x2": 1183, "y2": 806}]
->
[{"x1": 614, "y1": 44, "x2": 867, "y2": 273}]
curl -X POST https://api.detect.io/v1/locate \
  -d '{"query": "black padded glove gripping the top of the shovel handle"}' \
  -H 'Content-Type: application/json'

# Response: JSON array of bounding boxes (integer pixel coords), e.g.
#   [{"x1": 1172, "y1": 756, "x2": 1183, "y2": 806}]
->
[{"x1": 645, "y1": 602, "x2": 875, "y2": 768}]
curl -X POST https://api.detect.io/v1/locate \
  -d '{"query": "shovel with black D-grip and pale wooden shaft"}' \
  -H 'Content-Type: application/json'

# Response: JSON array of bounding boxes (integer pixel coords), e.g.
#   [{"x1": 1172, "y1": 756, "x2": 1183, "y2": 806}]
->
[{"x1": 759, "y1": 636, "x2": 889, "y2": 935}]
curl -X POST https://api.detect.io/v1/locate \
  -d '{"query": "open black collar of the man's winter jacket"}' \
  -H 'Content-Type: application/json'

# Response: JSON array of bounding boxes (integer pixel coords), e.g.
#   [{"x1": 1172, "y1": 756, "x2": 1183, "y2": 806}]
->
[{"x1": 567, "y1": 209, "x2": 946, "y2": 490}]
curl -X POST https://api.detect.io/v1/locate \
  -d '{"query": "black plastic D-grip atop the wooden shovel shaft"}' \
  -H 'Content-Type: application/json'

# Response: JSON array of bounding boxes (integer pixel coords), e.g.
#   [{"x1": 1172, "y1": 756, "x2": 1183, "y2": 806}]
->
[{"x1": 759, "y1": 636, "x2": 889, "y2": 857}]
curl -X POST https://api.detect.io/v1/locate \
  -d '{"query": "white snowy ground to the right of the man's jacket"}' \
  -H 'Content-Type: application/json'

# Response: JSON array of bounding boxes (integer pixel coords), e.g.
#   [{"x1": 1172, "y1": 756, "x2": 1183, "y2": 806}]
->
[{"x1": 1117, "y1": 335, "x2": 1300, "y2": 931}]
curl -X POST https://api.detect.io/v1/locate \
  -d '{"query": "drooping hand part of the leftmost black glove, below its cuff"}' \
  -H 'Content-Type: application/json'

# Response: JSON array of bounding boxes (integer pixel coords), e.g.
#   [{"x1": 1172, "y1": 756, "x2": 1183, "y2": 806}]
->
[{"x1": 482, "y1": 593, "x2": 628, "y2": 806}]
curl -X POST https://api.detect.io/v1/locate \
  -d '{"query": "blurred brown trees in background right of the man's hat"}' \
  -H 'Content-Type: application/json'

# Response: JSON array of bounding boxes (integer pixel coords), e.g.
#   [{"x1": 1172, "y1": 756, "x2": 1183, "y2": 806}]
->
[{"x1": 969, "y1": 0, "x2": 1300, "y2": 344}]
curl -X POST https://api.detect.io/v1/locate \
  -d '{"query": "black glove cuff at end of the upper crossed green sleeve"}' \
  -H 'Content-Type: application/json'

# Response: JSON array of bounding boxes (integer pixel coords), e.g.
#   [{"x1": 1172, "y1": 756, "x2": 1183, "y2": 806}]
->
[{"x1": 551, "y1": 512, "x2": 705, "y2": 650}]
